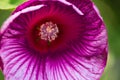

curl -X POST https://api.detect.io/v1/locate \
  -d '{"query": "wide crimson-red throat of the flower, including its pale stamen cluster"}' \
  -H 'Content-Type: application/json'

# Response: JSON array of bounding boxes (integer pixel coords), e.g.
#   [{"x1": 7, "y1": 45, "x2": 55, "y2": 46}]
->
[{"x1": 26, "y1": 1, "x2": 82, "y2": 53}]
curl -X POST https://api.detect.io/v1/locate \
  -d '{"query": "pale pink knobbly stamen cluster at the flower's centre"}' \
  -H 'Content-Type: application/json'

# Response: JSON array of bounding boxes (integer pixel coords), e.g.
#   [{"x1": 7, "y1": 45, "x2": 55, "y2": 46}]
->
[{"x1": 39, "y1": 22, "x2": 59, "y2": 42}]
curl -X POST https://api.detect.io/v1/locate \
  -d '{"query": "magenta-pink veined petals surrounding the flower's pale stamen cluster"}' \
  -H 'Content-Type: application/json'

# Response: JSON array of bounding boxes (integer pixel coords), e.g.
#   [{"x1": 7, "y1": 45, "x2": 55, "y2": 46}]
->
[{"x1": 0, "y1": 0, "x2": 108, "y2": 80}]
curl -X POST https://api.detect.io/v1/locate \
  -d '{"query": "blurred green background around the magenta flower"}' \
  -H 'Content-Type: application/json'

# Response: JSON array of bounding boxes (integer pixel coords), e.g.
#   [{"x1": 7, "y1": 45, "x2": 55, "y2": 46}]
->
[{"x1": 0, "y1": 0, "x2": 120, "y2": 80}]
